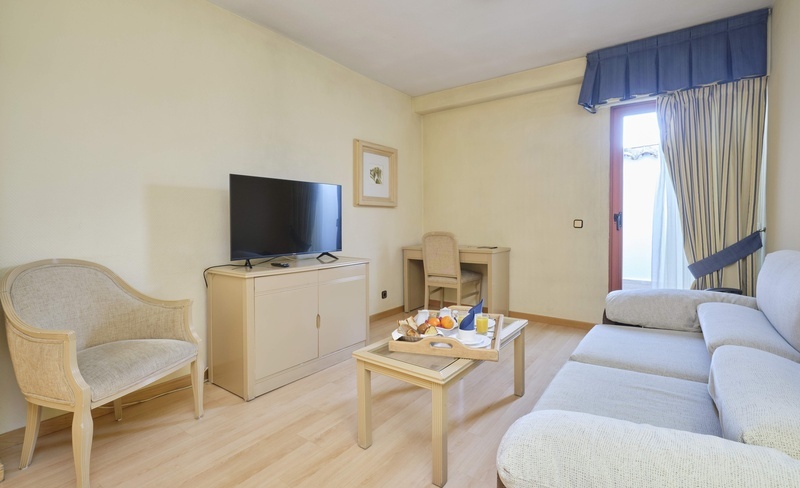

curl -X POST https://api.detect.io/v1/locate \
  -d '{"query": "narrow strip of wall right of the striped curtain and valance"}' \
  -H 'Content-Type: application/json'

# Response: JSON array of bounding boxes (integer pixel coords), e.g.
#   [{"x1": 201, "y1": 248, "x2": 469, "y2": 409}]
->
[{"x1": 766, "y1": 0, "x2": 800, "y2": 251}]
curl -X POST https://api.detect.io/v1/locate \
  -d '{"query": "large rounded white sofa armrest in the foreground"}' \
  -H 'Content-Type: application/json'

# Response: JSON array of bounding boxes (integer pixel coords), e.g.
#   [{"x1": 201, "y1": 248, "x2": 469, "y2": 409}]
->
[{"x1": 497, "y1": 410, "x2": 800, "y2": 488}]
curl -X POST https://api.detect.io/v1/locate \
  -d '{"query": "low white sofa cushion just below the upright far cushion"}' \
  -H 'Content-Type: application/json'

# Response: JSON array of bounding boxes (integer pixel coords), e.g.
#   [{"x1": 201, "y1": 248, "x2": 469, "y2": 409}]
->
[{"x1": 697, "y1": 303, "x2": 800, "y2": 362}]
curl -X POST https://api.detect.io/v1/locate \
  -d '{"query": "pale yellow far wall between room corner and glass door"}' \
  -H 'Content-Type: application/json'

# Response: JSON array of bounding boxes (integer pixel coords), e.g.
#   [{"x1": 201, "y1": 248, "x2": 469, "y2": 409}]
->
[{"x1": 423, "y1": 82, "x2": 609, "y2": 322}]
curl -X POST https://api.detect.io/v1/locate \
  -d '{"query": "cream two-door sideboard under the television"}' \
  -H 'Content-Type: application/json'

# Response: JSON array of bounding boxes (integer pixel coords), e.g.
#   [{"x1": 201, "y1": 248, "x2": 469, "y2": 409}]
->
[{"x1": 207, "y1": 257, "x2": 369, "y2": 400}]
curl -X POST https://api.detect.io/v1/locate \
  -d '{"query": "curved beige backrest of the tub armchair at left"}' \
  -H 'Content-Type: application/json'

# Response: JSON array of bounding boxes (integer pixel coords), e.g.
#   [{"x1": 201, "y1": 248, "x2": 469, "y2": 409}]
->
[{"x1": 2, "y1": 260, "x2": 180, "y2": 351}]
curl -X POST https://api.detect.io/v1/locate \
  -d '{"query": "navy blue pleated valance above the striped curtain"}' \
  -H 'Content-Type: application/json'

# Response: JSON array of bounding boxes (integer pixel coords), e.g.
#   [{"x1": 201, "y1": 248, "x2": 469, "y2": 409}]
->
[{"x1": 578, "y1": 9, "x2": 769, "y2": 113}]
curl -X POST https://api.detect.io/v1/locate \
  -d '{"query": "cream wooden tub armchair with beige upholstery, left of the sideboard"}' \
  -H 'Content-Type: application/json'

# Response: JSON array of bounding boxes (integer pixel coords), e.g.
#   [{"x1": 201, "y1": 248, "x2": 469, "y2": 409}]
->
[{"x1": 0, "y1": 260, "x2": 204, "y2": 487}]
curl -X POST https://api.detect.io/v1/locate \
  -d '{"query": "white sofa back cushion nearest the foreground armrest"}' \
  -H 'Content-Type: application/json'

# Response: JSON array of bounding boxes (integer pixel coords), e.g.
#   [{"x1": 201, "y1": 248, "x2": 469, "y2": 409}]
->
[{"x1": 708, "y1": 346, "x2": 800, "y2": 459}]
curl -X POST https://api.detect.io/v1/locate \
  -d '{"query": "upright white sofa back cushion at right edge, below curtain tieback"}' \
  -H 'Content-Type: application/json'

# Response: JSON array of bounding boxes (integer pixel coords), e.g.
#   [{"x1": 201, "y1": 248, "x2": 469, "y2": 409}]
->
[{"x1": 756, "y1": 251, "x2": 800, "y2": 349}]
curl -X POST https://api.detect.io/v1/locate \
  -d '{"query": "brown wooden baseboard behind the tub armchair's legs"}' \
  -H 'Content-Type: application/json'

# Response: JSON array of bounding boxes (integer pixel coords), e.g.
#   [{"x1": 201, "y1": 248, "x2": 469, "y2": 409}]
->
[{"x1": 0, "y1": 374, "x2": 197, "y2": 450}]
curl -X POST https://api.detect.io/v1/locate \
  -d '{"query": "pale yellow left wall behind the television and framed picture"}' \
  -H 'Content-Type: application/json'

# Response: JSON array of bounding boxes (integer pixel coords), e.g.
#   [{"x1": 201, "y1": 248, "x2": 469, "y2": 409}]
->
[{"x1": 0, "y1": 0, "x2": 422, "y2": 433}]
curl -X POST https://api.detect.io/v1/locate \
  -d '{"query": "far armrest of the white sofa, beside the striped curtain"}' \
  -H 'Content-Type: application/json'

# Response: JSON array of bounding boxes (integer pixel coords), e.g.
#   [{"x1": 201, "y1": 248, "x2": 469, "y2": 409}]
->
[{"x1": 605, "y1": 290, "x2": 757, "y2": 332}]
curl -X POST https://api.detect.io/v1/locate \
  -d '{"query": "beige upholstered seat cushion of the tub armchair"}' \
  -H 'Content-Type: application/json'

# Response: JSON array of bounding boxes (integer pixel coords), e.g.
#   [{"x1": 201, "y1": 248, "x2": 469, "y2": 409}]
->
[{"x1": 78, "y1": 339, "x2": 197, "y2": 402}]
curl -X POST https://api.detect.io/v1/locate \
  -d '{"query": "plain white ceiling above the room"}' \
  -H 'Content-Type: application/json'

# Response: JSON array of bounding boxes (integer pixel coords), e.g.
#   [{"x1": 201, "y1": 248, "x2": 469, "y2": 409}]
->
[{"x1": 210, "y1": 0, "x2": 773, "y2": 96}]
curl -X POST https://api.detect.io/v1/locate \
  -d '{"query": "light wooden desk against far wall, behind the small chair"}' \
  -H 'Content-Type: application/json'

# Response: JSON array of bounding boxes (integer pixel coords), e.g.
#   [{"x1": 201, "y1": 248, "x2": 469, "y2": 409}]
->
[{"x1": 403, "y1": 245, "x2": 511, "y2": 315}]
